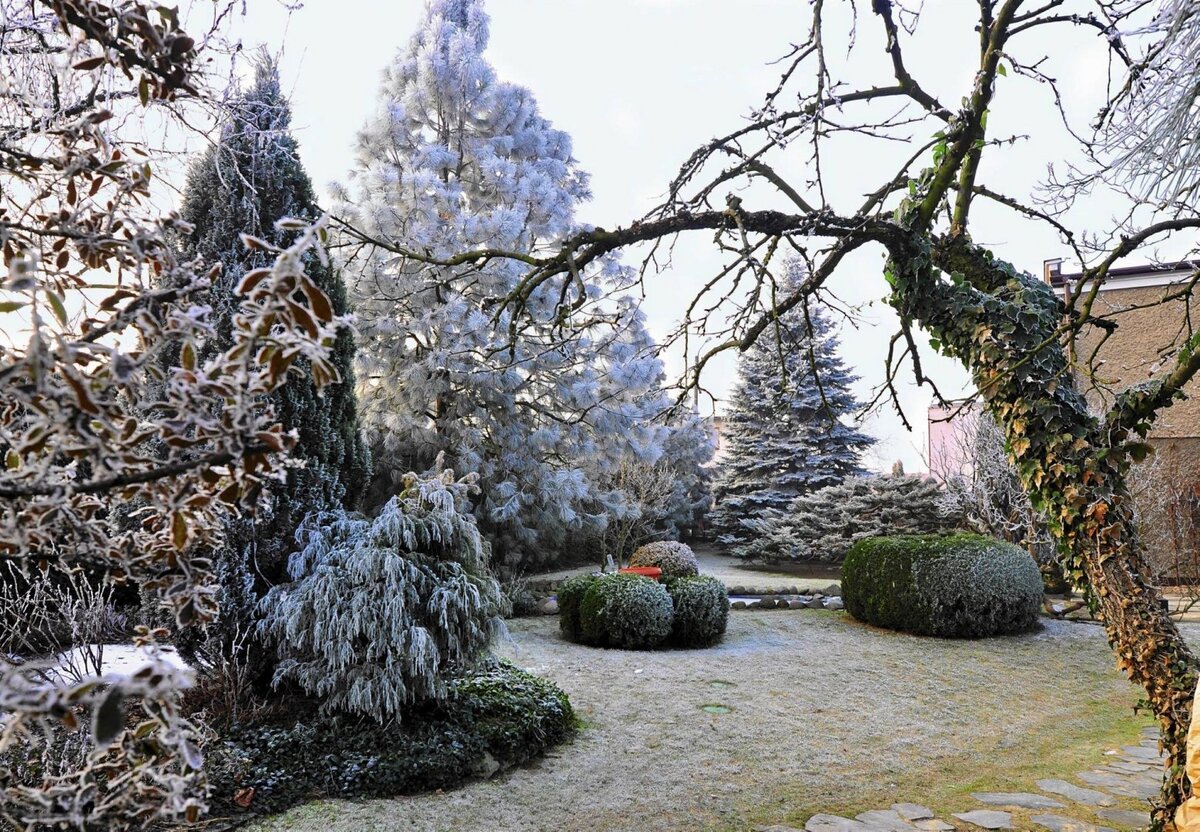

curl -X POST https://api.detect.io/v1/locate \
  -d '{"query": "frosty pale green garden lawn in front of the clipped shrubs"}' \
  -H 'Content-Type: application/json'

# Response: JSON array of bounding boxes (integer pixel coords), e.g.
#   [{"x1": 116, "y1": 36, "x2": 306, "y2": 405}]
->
[{"x1": 243, "y1": 611, "x2": 1161, "y2": 832}]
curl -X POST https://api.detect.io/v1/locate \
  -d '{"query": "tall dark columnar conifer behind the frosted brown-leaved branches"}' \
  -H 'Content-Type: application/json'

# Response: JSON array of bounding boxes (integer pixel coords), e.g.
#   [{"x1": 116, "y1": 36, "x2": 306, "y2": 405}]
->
[{"x1": 158, "y1": 58, "x2": 370, "y2": 660}]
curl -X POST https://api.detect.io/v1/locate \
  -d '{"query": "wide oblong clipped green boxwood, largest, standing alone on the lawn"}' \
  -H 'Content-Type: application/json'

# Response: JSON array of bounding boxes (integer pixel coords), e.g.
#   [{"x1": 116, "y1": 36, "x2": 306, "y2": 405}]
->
[{"x1": 841, "y1": 534, "x2": 1042, "y2": 639}]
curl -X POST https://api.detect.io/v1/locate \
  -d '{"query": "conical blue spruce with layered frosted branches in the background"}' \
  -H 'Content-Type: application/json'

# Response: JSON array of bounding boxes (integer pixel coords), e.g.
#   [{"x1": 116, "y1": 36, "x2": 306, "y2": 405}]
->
[{"x1": 710, "y1": 264, "x2": 874, "y2": 545}]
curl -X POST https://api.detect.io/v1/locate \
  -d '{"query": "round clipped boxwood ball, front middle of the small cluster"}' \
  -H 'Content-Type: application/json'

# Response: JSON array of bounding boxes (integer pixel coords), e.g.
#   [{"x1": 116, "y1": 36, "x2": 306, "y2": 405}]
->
[{"x1": 580, "y1": 574, "x2": 674, "y2": 650}]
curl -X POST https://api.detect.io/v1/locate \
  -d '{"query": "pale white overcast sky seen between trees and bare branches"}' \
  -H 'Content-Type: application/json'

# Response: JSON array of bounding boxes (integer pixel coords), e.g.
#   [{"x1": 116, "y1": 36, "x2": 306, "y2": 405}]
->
[{"x1": 211, "y1": 0, "x2": 1156, "y2": 469}]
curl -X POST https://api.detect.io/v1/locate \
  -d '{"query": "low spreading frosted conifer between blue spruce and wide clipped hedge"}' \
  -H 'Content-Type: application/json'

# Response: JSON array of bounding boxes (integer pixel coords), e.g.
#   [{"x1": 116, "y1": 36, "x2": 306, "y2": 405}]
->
[{"x1": 732, "y1": 472, "x2": 960, "y2": 563}]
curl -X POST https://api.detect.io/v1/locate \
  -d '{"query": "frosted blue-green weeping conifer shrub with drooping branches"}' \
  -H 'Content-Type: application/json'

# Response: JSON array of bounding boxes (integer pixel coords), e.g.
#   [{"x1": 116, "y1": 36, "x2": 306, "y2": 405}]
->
[{"x1": 259, "y1": 471, "x2": 503, "y2": 723}]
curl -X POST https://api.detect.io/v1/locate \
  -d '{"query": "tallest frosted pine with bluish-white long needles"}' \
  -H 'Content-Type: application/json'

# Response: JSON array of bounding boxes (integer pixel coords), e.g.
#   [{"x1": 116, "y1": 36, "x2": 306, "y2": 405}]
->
[{"x1": 346, "y1": 0, "x2": 665, "y2": 567}]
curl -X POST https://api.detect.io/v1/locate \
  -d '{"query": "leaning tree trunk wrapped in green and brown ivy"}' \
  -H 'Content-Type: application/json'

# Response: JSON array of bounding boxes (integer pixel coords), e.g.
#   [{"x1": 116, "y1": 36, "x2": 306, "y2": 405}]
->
[{"x1": 889, "y1": 235, "x2": 1196, "y2": 828}]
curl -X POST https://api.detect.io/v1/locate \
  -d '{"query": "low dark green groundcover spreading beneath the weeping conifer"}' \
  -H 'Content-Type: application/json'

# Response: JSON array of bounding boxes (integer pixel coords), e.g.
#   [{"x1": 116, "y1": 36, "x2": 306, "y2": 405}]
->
[{"x1": 204, "y1": 662, "x2": 575, "y2": 816}]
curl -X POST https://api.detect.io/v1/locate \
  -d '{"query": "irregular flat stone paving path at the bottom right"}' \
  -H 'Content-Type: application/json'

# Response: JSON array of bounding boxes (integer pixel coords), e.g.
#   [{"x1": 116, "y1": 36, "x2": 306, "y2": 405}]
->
[{"x1": 755, "y1": 728, "x2": 1164, "y2": 832}]
